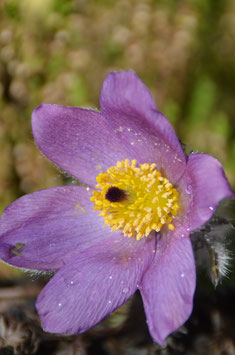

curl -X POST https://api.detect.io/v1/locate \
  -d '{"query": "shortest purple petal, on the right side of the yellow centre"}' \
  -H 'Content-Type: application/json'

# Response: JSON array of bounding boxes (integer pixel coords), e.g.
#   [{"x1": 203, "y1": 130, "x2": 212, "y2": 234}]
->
[{"x1": 179, "y1": 154, "x2": 234, "y2": 230}]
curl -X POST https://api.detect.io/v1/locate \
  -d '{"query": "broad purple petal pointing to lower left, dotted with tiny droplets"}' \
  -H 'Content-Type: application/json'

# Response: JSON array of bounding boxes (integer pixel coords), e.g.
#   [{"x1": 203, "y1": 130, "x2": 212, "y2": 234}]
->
[{"x1": 36, "y1": 236, "x2": 155, "y2": 334}]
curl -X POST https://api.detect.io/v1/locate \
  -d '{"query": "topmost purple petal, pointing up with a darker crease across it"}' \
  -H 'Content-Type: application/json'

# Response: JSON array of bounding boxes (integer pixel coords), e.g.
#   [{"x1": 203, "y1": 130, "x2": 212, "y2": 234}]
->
[{"x1": 100, "y1": 71, "x2": 185, "y2": 183}]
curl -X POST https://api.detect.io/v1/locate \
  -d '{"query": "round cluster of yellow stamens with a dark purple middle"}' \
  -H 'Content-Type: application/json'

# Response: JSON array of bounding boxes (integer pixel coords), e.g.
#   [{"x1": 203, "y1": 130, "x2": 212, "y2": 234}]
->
[{"x1": 91, "y1": 159, "x2": 179, "y2": 240}]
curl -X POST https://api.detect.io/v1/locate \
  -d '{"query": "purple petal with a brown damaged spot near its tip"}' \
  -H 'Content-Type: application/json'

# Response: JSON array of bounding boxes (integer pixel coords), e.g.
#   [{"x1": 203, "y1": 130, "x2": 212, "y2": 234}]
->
[{"x1": 0, "y1": 186, "x2": 116, "y2": 270}]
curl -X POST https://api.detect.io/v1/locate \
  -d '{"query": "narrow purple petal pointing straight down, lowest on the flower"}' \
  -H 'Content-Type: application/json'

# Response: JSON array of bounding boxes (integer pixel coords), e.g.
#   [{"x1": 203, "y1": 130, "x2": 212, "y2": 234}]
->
[{"x1": 140, "y1": 229, "x2": 196, "y2": 345}]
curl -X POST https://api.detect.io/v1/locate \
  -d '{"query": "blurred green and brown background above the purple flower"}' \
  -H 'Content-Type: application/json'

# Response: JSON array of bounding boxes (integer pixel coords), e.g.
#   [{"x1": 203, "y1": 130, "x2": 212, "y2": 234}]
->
[{"x1": 0, "y1": 0, "x2": 235, "y2": 217}]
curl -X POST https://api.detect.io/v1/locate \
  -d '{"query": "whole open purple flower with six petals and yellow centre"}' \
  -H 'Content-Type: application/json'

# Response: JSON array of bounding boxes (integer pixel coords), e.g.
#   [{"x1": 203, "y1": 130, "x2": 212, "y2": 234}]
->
[{"x1": 0, "y1": 71, "x2": 233, "y2": 345}]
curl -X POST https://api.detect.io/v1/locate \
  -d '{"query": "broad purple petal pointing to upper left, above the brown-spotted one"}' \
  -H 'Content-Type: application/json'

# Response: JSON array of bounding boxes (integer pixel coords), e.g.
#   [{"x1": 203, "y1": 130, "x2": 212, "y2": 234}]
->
[{"x1": 32, "y1": 104, "x2": 145, "y2": 186}]
